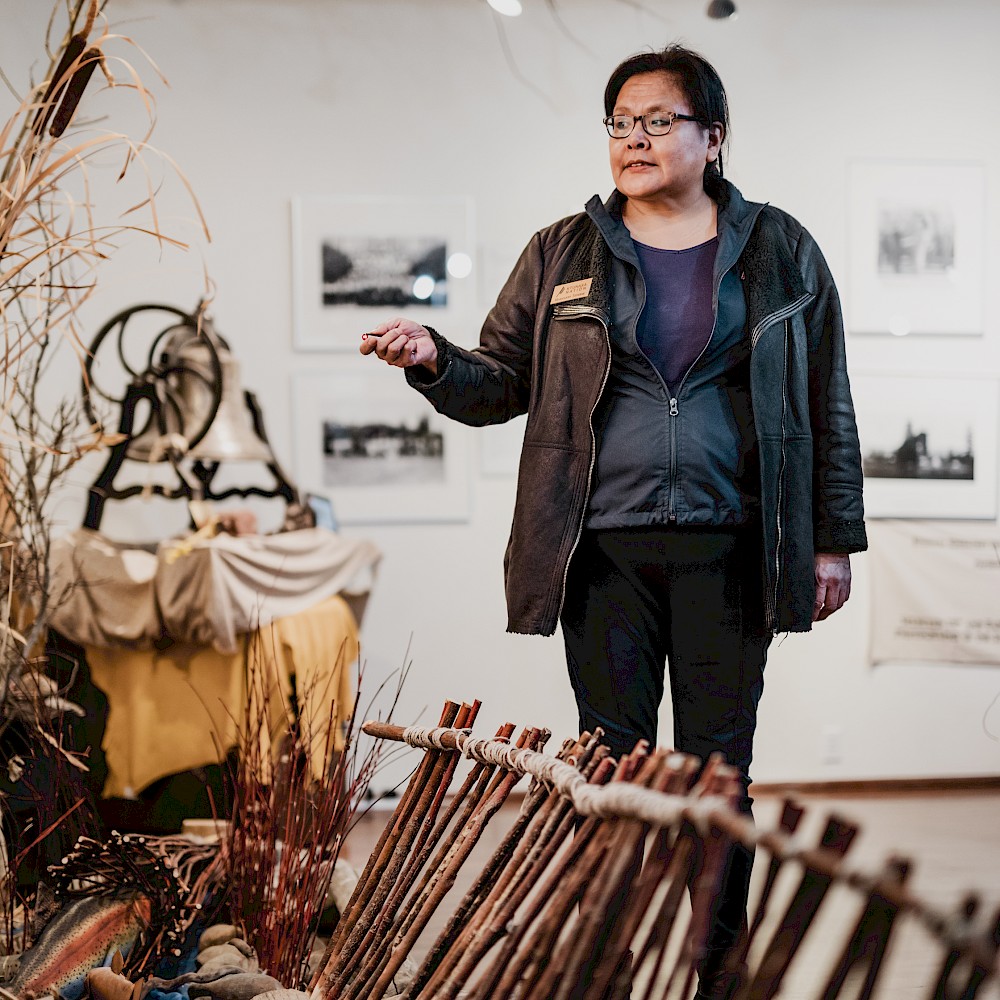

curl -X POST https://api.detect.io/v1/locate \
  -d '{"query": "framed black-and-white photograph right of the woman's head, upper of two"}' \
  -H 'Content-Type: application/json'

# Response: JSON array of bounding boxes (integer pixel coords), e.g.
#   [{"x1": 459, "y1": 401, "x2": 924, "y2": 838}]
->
[{"x1": 844, "y1": 161, "x2": 986, "y2": 336}]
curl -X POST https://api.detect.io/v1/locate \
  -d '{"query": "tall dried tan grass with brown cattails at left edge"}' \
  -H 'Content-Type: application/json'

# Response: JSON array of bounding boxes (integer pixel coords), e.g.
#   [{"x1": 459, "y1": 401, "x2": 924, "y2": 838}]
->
[{"x1": 0, "y1": 0, "x2": 208, "y2": 936}]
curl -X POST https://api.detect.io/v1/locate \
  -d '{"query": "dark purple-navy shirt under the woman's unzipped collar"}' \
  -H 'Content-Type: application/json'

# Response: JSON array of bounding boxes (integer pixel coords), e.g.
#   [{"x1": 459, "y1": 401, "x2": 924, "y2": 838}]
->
[{"x1": 632, "y1": 236, "x2": 719, "y2": 395}]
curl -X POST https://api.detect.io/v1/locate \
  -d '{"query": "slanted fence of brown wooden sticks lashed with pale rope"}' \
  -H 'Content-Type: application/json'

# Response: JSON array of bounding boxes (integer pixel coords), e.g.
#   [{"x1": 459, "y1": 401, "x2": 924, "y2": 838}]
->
[{"x1": 312, "y1": 702, "x2": 1000, "y2": 1000}]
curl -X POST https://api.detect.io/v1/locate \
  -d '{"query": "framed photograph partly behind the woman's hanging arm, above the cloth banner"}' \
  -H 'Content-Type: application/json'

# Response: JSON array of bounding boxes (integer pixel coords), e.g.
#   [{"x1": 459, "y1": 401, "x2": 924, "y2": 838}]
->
[{"x1": 851, "y1": 373, "x2": 1000, "y2": 519}]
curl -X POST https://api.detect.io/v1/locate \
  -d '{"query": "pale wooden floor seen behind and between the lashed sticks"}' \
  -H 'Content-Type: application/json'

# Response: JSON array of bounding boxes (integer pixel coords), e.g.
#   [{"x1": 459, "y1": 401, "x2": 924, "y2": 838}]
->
[{"x1": 346, "y1": 790, "x2": 1000, "y2": 1000}]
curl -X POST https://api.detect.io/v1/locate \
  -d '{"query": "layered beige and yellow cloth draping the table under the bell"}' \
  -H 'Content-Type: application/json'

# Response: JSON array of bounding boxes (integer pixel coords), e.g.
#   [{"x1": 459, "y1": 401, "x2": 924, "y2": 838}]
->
[{"x1": 50, "y1": 528, "x2": 380, "y2": 796}]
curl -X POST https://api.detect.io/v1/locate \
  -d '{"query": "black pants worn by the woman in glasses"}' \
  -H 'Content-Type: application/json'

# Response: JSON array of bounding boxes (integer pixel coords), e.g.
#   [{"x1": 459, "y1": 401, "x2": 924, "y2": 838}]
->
[{"x1": 561, "y1": 526, "x2": 770, "y2": 953}]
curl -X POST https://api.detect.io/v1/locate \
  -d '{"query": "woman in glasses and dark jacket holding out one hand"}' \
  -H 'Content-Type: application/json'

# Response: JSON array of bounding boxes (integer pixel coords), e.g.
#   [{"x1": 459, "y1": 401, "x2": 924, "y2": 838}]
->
[{"x1": 361, "y1": 46, "x2": 866, "y2": 998}]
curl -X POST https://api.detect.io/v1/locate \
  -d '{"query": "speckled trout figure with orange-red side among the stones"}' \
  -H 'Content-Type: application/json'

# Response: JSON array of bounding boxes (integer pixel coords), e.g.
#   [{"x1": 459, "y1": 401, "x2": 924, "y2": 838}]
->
[{"x1": 5, "y1": 895, "x2": 150, "y2": 1000}]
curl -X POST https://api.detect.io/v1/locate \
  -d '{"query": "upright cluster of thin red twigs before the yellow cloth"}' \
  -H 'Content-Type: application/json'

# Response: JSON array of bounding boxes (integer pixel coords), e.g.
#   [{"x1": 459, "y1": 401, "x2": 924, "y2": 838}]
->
[{"x1": 221, "y1": 636, "x2": 406, "y2": 988}]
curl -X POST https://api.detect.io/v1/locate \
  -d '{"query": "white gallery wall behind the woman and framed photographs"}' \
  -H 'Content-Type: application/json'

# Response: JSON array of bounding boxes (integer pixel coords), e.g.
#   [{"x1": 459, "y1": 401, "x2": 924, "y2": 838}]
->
[{"x1": 0, "y1": 0, "x2": 1000, "y2": 782}]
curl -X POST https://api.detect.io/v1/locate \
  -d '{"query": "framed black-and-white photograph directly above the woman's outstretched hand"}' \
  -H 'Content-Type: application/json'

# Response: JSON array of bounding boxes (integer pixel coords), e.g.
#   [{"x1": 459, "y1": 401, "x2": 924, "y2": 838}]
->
[{"x1": 292, "y1": 197, "x2": 476, "y2": 351}]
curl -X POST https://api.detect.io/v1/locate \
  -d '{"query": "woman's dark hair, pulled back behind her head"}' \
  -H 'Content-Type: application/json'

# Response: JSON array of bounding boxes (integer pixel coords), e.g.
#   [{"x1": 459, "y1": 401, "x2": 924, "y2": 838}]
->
[{"x1": 604, "y1": 45, "x2": 729, "y2": 201}]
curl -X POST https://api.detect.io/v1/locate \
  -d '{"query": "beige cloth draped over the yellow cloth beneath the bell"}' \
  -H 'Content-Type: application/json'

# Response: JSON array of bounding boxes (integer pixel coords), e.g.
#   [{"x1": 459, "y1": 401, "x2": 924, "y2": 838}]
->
[{"x1": 50, "y1": 528, "x2": 381, "y2": 653}]
